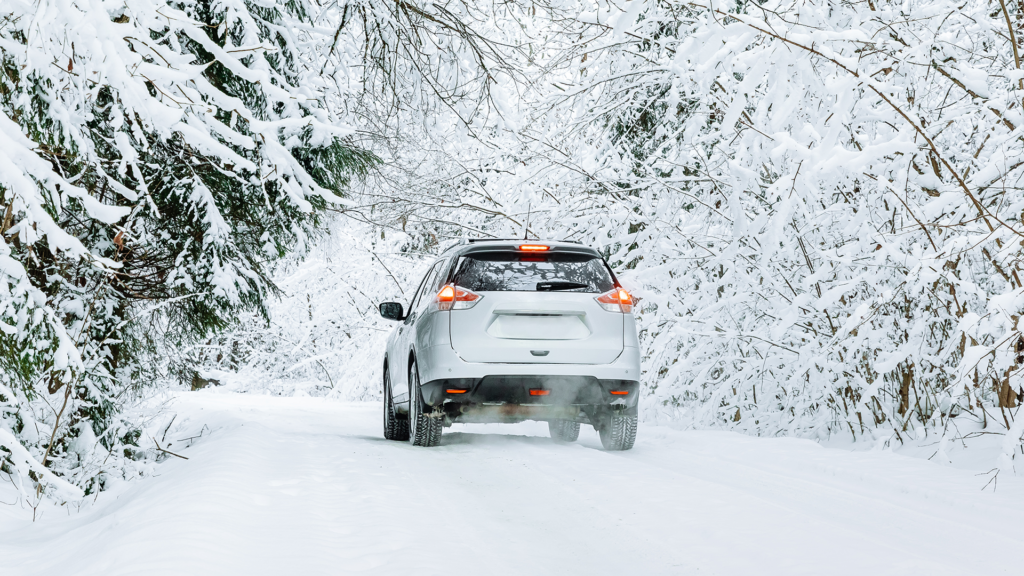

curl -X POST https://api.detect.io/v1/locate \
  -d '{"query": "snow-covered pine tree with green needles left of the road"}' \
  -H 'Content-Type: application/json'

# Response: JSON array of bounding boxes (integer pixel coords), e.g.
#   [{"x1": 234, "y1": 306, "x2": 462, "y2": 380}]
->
[{"x1": 0, "y1": 0, "x2": 375, "y2": 495}]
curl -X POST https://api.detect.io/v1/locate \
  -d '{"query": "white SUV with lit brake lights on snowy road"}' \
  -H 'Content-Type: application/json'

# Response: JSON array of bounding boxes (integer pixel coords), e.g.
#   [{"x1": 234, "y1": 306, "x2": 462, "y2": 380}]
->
[{"x1": 380, "y1": 240, "x2": 640, "y2": 450}]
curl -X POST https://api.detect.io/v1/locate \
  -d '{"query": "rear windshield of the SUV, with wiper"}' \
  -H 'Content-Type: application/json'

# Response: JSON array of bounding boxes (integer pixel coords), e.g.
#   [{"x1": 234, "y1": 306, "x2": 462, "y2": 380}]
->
[{"x1": 454, "y1": 252, "x2": 614, "y2": 293}]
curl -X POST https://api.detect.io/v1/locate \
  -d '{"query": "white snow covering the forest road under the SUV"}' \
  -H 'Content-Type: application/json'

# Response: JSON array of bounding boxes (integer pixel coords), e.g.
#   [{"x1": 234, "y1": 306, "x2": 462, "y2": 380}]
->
[{"x1": 0, "y1": 390, "x2": 1024, "y2": 576}]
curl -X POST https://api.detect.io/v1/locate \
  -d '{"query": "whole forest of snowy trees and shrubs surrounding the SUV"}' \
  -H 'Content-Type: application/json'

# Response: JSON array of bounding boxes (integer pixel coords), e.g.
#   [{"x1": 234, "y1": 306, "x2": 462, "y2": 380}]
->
[{"x1": 0, "y1": 0, "x2": 1024, "y2": 499}]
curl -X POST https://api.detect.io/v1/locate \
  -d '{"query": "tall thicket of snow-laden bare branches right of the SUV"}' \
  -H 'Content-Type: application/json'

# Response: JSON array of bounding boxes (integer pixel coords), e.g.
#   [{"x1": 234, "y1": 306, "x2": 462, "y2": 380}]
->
[{"x1": 488, "y1": 0, "x2": 1024, "y2": 456}]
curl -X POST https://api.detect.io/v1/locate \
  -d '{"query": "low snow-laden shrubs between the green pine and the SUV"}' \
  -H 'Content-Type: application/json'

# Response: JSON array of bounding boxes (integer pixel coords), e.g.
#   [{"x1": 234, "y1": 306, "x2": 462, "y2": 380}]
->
[{"x1": 188, "y1": 223, "x2": 430, "y2": 401}]
